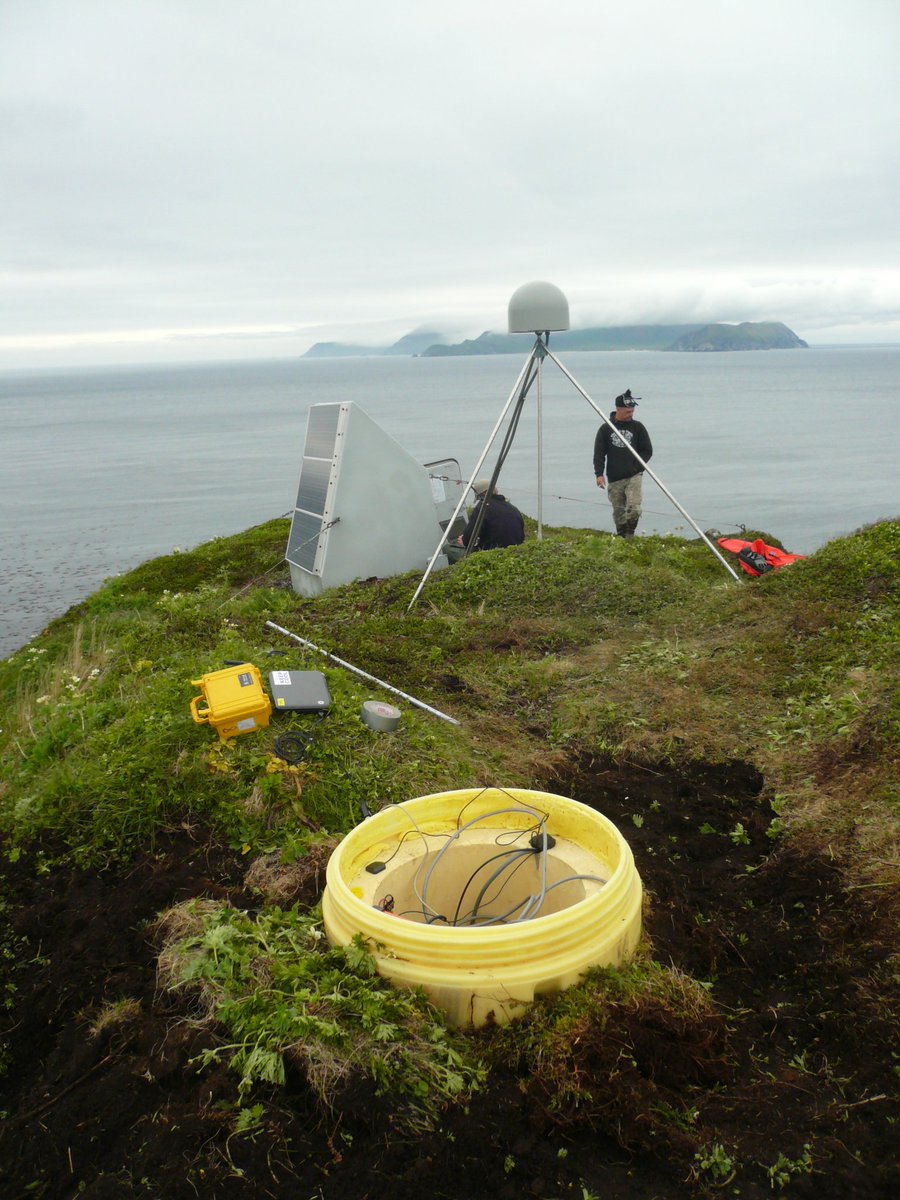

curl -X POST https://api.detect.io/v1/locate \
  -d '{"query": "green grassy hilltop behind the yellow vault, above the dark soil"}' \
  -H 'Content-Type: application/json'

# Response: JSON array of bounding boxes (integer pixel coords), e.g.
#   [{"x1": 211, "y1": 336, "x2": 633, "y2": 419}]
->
[{"x1": 0, "y1": 521, "x2": 900, "y2": 863}]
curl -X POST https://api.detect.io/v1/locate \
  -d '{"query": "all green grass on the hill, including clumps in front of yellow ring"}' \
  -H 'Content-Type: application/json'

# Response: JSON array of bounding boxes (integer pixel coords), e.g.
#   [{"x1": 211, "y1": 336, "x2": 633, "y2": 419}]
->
[{"x1": 0, "y1": 521, "x2": 900, "y2": 1123}]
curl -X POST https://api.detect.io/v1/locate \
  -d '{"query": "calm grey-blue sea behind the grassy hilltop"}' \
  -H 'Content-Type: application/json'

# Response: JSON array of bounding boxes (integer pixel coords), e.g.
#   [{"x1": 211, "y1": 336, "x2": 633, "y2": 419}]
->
[{"x1": 0, "y1": 340, "x2": 900, "y2": 655}]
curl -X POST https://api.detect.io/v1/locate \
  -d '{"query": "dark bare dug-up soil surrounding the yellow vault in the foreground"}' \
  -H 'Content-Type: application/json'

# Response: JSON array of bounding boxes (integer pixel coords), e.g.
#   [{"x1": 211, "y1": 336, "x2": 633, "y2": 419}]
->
[{"x1": 0, "y1": 762, "x2": 900, "y2": 1200}]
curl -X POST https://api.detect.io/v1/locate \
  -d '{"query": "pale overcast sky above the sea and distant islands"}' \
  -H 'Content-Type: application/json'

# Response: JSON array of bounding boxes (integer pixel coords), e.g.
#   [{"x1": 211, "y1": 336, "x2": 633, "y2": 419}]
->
[{"x1": 0, "y1": 0, "x2": 900, "y2": 367}]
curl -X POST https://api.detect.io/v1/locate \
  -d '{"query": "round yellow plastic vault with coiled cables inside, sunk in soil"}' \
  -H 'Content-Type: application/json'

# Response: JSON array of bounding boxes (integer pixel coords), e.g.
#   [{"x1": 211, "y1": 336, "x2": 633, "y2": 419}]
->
[{"x1": 322, "y1": 787, "x2": 642, "y2": 1026}]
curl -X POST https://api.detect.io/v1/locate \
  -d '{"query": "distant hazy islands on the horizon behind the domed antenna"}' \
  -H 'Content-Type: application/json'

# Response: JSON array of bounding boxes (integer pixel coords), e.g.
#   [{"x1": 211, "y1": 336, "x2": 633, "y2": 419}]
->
[{"x1": 304, "y1": 320, "x2": 809, "y2": 359}]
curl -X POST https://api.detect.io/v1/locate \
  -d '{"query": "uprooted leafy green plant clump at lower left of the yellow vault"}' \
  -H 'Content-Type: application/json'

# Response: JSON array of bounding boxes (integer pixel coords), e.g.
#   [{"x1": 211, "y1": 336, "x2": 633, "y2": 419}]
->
[{"x1": 160, "y1": 905, "x2": 484, "y2": 1128}]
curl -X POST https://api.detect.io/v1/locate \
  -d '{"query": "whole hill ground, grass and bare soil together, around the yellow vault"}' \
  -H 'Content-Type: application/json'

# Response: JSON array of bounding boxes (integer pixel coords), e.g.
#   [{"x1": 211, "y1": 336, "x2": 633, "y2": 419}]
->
[{"x1": 0, "y1": 521, "x2": 900, "y2": 1200}]
